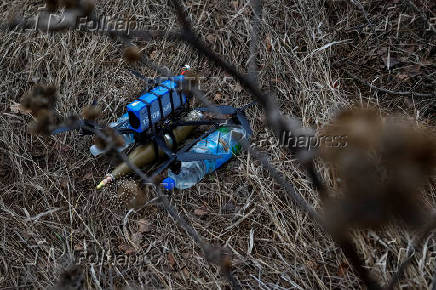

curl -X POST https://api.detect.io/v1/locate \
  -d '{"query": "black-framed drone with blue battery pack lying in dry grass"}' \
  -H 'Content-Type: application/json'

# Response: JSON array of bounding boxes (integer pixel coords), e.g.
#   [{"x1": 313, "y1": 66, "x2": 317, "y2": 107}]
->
[{"x1": 52, "y1": 66, "x2": 254, "y2": 176}]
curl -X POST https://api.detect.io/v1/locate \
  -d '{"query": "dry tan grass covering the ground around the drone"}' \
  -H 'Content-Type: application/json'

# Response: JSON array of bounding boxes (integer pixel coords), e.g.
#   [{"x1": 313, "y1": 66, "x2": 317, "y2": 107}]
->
[{"x1": 0, "y1": 0, "x2": 436, "y2": 289}]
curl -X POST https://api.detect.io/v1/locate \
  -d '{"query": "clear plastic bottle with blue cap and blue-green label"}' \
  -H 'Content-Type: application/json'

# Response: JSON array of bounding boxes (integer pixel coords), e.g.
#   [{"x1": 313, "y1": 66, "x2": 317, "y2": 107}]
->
[{"x1": 162, "y1": 127, "x2": 247, "y2": 190}]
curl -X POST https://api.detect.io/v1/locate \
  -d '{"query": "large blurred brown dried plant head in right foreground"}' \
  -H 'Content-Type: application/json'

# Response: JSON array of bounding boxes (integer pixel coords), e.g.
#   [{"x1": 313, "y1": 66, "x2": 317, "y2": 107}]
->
[{"x1": 321, "y1": 109, "x2": 436, "y2": 229}]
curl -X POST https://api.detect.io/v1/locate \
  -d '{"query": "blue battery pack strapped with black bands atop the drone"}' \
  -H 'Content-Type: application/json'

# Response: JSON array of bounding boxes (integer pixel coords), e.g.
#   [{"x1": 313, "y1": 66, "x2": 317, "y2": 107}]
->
[{"x1": 127, "y1": 75, "x2": 186, "y2": 133}]
